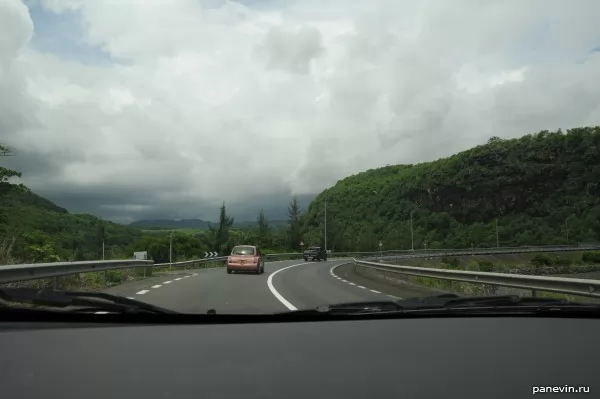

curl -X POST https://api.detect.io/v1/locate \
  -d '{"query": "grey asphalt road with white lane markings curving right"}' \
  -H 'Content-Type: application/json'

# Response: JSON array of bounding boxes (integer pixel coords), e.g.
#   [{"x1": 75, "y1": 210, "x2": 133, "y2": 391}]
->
[{"x1": 104, "y1": 259, "x2": 438, "y2": 314}]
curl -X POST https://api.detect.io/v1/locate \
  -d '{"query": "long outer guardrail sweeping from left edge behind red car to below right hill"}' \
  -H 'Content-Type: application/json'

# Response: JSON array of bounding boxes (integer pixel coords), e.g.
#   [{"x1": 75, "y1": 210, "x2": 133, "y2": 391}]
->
[{"x1": 0, "y1": 246, "x2": 600, "y2": 284}]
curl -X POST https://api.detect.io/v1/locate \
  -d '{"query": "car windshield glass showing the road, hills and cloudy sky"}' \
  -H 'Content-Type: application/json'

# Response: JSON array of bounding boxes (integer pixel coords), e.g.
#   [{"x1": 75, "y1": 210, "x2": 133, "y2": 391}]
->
[{"x1": 0, "y1": 0, "x2": 600, "y2": 314}]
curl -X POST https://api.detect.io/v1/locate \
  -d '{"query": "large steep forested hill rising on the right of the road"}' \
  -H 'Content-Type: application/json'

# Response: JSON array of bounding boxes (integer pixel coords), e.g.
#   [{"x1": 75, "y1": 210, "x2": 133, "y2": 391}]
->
[{"x1": 303, "y1": 127, "x2": 600, "y2": 251}]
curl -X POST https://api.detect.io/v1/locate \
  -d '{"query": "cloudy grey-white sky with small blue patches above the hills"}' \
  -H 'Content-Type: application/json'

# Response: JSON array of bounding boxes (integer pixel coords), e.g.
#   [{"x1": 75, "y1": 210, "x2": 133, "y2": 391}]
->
[{"x1": 0, "y1": 0, "x2": 600, "y2": 223}]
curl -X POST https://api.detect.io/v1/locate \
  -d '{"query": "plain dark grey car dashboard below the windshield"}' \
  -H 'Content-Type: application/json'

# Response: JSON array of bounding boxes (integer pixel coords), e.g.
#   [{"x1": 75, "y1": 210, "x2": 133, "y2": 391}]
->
[{"x1": 0, "y1": 317, "x2": 600, "y2": 399}]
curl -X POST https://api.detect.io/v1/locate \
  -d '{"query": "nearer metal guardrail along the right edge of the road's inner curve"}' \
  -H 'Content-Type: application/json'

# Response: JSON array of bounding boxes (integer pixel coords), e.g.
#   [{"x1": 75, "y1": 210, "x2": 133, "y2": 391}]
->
[{"x1": 354, "y1": 259, "x2": 600, "y2": 298}]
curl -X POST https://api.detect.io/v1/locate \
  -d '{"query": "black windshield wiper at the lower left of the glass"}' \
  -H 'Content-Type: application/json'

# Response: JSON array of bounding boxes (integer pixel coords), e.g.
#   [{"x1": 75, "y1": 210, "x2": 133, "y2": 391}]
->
[{"x1": 0, "y1": 288, "x2": 177, "y2": 314}]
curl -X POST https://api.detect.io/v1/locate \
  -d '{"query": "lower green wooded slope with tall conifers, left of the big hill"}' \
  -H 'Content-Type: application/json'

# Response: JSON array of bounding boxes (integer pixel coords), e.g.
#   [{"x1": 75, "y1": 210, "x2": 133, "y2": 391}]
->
[{"x1": 0, "y1": 145, "x2": 299, "y2": 264}]
